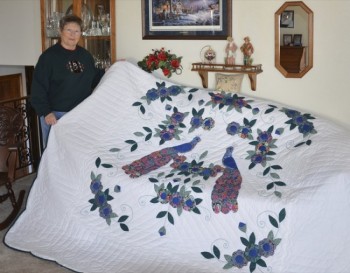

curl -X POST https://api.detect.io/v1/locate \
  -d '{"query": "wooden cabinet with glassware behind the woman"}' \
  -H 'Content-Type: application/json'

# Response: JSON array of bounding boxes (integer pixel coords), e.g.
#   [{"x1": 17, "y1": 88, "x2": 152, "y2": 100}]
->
[{"x1": 40, "y1": 0, "x2": 116, "y2": 68}]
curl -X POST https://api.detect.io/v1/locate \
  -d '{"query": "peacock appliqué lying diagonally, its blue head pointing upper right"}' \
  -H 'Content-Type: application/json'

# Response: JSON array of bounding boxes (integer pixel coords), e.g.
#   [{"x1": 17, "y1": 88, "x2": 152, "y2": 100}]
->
[{"x1": 122, "y1": 136, "x2": 201, "y2": 178}]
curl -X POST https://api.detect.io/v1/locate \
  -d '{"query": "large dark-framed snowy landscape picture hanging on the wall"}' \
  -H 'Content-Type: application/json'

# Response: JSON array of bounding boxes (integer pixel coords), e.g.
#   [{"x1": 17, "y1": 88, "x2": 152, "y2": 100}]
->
[{"x1": 141, "y1": 0, "x2": 232, "y2": 40}]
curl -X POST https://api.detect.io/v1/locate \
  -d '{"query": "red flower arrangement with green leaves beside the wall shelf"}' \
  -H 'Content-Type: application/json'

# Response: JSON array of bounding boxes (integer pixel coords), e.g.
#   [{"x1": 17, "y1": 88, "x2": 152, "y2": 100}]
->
[{"x1": 137, "y1": 47, "x2": 182, "y2": 78}]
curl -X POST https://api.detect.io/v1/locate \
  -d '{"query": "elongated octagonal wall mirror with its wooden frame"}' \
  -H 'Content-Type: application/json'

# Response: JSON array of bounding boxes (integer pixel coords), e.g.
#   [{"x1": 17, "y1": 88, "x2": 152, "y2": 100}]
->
[{"x1": 275, "y1": 1, "x2": 314, "y2": 78}]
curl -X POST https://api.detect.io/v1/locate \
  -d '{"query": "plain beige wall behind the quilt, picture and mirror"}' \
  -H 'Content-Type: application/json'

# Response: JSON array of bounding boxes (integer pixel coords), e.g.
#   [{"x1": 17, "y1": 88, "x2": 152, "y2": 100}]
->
[{"x1": 0, "y1": 0, "x2": 350, "y2": 128}]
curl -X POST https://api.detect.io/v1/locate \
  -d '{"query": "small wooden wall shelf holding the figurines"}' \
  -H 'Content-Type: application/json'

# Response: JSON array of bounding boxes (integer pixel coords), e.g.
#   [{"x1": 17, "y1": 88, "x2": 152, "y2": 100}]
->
[{"x1": 191, "y1": 63, "x2": 263, "y2": 91}]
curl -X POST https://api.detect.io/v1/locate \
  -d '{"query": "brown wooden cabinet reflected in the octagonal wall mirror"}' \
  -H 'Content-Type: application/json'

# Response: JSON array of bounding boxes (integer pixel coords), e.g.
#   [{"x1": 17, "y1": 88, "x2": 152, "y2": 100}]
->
[{"x1": 280, "y1": 46, "x2": 306, "y2": 73}]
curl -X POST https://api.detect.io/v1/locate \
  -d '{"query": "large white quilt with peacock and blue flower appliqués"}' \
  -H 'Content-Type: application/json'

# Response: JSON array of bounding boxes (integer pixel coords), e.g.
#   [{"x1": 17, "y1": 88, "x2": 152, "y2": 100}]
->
[{"x1": 5, "y1": 62, "x2": 350, "y2": 273}]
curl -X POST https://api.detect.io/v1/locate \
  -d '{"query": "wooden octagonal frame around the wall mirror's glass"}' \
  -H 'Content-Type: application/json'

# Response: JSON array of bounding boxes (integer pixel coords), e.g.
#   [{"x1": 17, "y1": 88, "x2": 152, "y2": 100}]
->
[{"x1": 275, "y1": 1, "x2": 314, "y2": 78}]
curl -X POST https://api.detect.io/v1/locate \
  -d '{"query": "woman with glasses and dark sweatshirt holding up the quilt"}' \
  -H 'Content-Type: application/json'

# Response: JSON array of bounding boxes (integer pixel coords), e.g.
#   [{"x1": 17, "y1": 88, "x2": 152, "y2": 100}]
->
[{"x1": 31, "y1": 15, "x2": 105, "y2": 148}]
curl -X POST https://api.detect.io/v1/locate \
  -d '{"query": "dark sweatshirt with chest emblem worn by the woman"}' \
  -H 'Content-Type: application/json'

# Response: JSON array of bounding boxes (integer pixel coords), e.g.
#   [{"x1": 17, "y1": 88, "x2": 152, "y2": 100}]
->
[{"x1": 31, "y1": 43, "x2": 104, "y2": 116}]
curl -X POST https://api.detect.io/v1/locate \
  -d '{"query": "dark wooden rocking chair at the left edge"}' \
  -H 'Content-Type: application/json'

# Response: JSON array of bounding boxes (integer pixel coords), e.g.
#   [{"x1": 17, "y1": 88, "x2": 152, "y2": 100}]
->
[{"x1": 0, "y1": 105, "x2": 25, "y2": 230}]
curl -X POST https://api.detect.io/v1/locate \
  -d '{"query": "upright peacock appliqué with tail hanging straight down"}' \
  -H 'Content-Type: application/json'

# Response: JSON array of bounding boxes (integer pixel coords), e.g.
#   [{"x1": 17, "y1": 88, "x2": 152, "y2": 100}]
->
[{"x1": 211, "y1": 147, "x2": 242, "y2": 214}]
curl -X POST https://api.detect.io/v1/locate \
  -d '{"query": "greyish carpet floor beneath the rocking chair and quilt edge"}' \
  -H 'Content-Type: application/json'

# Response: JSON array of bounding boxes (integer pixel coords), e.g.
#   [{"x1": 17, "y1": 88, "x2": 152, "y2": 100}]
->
[{"x1": 0, "y1": 174, "x2": 74, "y2": 273}]
